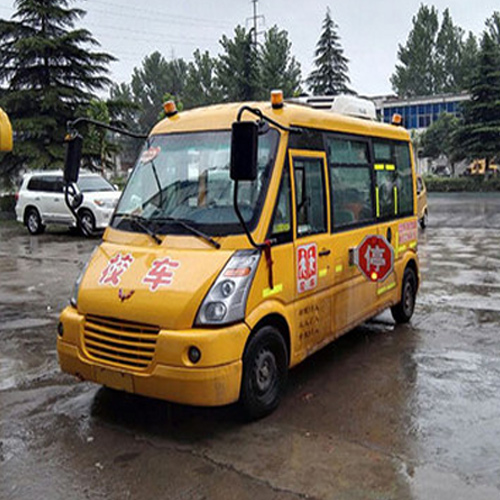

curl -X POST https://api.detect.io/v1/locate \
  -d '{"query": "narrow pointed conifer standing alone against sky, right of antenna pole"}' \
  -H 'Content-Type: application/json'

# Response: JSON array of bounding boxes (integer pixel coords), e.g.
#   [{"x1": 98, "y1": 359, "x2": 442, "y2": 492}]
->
[{"x1": 307, "y1": 8, "x2": 354, "y2": 95}]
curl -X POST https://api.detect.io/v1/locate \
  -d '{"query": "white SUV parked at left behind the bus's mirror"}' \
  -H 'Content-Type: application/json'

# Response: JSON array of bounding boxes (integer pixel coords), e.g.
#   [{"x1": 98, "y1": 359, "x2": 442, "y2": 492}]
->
[{"x1": 16, "y1": 171, "x2": 121, "y2": 234}]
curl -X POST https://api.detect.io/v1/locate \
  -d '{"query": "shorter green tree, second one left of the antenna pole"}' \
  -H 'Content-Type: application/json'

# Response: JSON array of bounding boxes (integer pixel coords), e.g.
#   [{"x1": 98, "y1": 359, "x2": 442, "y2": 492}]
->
[{"x1": 183, "y1": 49, "x2": 222, "y2": 109}]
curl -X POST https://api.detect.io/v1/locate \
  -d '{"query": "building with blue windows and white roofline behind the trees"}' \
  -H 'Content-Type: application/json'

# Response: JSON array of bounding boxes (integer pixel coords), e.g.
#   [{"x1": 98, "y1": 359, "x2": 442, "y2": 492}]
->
[{"x1": 372, "y1": 92, "x2": 470, "y2": 130}]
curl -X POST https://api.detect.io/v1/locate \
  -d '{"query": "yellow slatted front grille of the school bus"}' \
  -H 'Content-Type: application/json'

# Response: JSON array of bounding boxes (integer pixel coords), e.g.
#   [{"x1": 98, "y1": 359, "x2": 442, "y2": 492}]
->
[{"x1": 83, "y1": 315, "x2": 160, "y2": 370}]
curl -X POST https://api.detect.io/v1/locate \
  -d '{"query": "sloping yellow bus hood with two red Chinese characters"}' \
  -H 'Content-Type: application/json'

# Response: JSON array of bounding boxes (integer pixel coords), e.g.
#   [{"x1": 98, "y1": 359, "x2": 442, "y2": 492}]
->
[{"x1": 78, "y1": 242, "x2": 233, "y2": 330}]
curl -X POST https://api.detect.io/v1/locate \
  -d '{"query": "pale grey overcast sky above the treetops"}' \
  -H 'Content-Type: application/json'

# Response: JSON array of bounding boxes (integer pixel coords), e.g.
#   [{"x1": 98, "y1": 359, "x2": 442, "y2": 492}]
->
[{"x1": 0, "y1": 0, "x2": 500, "y2": 95}]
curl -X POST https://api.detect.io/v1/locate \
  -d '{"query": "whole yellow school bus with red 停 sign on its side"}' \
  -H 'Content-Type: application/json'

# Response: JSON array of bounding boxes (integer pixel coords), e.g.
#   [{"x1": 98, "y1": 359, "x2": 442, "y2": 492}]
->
[{"x1": 57, "y1": 94, "x2": 420, "y2": 418}]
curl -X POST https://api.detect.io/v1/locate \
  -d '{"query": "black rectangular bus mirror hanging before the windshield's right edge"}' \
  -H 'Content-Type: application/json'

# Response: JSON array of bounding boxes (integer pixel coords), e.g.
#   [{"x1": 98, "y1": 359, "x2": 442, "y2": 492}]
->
[{"x1": 230, "y1": 121, "x2": 259, "y2": 181}]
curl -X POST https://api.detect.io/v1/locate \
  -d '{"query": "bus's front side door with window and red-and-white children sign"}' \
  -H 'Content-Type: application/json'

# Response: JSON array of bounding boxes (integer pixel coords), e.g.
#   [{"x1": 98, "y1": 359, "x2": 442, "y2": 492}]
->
[{"x1": 289, "y1": 150, "x2": 333, "y2": 352}]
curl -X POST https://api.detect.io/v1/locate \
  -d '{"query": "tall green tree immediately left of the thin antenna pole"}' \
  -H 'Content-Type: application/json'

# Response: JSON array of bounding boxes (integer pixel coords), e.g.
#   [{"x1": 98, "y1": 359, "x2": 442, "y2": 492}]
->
[{"x1": 217, "y1": 26, "x2": 260, "y2": 101}]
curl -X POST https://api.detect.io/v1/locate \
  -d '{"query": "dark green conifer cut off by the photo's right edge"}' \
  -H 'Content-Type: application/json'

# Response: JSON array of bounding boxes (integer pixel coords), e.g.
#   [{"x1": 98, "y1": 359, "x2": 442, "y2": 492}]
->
[{"x1": 457, "y1": 31, "x2": 500, "y2": 167}]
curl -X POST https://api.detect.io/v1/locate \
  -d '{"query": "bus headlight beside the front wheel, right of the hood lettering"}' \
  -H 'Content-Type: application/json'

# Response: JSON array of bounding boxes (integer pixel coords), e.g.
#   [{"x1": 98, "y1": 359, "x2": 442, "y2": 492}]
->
[{"x1": 195, "y1": 250, "x2": 260, "y2": 326}]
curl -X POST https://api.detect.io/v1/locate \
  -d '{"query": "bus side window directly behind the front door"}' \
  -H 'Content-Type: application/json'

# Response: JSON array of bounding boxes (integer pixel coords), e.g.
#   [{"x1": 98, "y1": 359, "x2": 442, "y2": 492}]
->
[{"x1": 326, "y1": 135, "x2": 374, "y2": 228}]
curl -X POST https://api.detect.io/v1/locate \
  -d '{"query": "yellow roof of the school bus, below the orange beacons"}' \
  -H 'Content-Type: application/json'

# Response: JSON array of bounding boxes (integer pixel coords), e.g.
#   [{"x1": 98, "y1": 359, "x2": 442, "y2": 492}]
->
[{"x1": 151, "y1": 102, "x2": 410, "y2": 141}]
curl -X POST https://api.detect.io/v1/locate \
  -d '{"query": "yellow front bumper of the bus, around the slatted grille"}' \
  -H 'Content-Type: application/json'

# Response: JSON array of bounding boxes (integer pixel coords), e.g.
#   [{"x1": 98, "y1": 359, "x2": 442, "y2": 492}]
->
[{"x1": 57, "y1": 307, "x2": 250, "y2": 406}]
